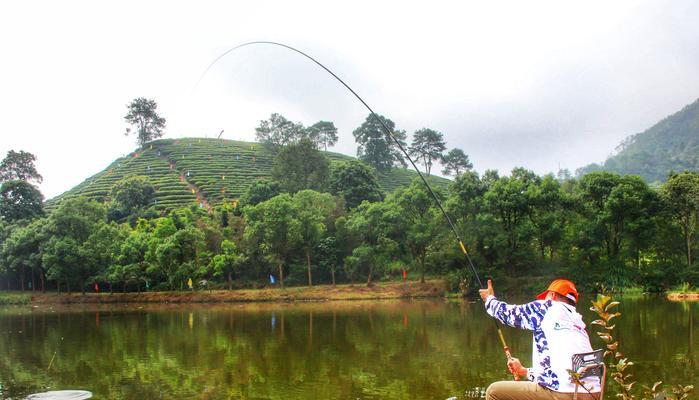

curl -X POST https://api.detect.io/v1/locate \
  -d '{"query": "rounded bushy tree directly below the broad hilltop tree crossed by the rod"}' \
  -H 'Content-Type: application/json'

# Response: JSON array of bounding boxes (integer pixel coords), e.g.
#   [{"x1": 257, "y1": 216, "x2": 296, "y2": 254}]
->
[{"x1": 330, "y1": 160, "x2": 383, "y2": 210}]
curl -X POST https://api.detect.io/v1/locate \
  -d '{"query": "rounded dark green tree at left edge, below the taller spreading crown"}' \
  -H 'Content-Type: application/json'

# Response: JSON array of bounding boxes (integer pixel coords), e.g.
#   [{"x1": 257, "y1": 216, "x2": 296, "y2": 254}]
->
[{"x1": 0, "y1": 181, "x2": 44, "y2": 222}]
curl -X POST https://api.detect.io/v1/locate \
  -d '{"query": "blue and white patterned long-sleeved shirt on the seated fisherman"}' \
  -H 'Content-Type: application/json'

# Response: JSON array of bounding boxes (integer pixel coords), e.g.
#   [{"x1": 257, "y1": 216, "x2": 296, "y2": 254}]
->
[{"x1": 485, "y1": 296, "x2": 600, "y2": 393}]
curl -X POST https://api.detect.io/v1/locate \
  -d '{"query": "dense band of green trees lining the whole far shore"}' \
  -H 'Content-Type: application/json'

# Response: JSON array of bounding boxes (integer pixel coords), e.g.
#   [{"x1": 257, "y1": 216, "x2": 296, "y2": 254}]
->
[{"x1": 0, "y1": 144, "x2": 699, "y2": 291}]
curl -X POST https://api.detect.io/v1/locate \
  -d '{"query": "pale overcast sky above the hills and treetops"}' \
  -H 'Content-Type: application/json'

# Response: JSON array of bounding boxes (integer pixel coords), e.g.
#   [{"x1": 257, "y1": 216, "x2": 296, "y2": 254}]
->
[{"x1": 0, "y1": 0, "x2": 699, "y2": 198}]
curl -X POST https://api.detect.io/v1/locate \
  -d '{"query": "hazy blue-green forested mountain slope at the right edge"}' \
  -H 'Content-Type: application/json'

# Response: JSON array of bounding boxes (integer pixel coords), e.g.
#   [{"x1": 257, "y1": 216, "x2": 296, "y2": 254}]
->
[{"x1": 577, "y1": 100, "x2": 699, "y2": 182}]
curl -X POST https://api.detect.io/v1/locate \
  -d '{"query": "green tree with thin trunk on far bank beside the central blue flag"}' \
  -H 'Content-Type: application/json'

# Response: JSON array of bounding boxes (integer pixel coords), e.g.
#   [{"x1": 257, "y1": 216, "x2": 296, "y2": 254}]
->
[{"x1": 244, "y1": 193, "x2": 300, "y2": 288}]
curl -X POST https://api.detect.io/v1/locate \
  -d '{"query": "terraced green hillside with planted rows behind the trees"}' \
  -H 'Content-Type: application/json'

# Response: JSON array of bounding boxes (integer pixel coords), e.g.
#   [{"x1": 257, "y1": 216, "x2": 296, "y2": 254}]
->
[{"x1": 46, "y1": 138, "x2": 450, "y2": 210}]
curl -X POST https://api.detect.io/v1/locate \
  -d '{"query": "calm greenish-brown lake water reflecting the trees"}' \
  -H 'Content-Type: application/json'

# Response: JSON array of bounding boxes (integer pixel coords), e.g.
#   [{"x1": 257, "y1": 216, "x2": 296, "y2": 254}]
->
[{"x1": 0, "y1": 297, "x2": 699, "y2": 399}]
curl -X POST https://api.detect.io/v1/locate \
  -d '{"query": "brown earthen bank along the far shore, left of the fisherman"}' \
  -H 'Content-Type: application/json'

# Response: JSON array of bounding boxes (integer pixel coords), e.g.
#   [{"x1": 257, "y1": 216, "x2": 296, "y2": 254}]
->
[{"x1": 0, "y1": 280, "x2": 445, "y2": 305}]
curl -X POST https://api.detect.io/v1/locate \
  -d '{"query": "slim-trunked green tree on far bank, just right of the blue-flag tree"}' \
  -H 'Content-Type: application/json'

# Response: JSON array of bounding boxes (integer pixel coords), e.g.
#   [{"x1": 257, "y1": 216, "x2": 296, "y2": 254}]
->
[{"x1": 293, "y1": 190, "x2": 336, "y2": 286}]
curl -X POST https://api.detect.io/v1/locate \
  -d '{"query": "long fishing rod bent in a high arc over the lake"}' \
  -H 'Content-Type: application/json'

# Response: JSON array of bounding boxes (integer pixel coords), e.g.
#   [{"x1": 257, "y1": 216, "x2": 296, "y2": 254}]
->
[{"x1": 192, "y1": 41, "x2": 519, "y2": 380}]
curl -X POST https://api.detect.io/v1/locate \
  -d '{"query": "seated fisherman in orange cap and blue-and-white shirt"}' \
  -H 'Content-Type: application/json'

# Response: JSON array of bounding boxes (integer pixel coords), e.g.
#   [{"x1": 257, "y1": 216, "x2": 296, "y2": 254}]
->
[{"x1": 480, "y1": 279, "x2": 600, "y2": 400}]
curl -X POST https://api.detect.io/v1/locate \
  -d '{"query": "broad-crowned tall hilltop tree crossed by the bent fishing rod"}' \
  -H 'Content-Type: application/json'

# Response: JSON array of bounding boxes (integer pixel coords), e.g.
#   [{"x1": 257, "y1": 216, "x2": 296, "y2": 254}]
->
[{"x1": 352, "y1": 114, "x2": 406, "y2": 171}]
